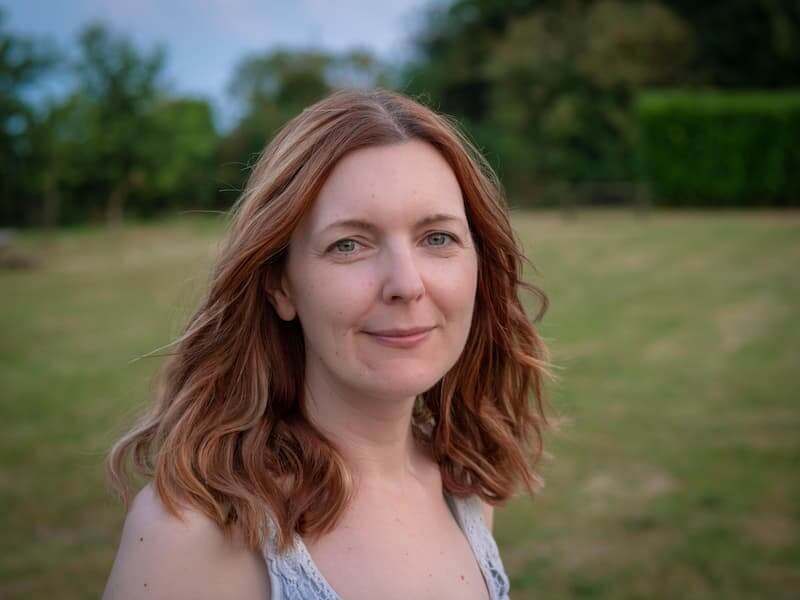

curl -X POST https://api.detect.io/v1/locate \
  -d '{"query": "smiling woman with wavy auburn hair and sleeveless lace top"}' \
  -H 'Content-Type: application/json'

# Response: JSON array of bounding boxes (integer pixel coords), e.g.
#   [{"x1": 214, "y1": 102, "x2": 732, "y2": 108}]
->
[{"x1": 105, "y1": 90, "x2": 550, "y2": 600}]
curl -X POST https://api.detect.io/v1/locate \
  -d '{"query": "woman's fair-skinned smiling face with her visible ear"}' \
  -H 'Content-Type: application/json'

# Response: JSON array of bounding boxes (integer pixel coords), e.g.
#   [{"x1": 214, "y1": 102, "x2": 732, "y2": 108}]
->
[{"x1": 272, "y1": 140, "x2": 478, "y2": 398}]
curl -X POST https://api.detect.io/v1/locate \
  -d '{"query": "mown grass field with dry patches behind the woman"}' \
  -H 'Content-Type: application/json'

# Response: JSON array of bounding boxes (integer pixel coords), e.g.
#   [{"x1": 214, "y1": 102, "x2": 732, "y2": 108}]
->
[{"x1": 0, "y1": 212, "x2": 800, "y2": 600}]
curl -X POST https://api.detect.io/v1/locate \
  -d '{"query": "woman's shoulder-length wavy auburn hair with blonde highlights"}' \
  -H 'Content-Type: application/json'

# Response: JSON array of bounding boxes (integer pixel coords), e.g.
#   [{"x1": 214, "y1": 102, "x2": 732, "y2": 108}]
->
[{"x1": 107, "y1": 90, "x2": 553, "y2": 551}]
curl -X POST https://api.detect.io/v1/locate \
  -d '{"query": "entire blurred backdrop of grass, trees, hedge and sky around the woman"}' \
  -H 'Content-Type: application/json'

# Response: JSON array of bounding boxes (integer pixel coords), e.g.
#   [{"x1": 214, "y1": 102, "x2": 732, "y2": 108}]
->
[{"x1": 0, "y1": 0, "x2": 800, "y2": 599}]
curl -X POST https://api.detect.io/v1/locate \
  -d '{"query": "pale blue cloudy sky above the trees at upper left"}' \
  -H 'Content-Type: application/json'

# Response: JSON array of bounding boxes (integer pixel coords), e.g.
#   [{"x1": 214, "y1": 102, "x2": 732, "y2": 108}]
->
[{"x1": 0, "y1": 0, "x2": 435, "y2": 124}]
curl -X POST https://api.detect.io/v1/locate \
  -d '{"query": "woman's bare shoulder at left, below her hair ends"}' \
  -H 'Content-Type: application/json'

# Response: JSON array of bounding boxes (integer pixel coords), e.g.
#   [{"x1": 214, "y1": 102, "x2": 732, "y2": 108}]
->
[{"x1": 103, "y1": 485, "x2": 269, "y2": 600}]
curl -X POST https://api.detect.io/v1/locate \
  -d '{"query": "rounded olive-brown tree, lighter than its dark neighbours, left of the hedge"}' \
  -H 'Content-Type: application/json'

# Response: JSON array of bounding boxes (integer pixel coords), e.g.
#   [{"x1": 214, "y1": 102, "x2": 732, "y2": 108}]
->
[{"x1": 484, "y1": 0, "x2": 694, "y2": 190}]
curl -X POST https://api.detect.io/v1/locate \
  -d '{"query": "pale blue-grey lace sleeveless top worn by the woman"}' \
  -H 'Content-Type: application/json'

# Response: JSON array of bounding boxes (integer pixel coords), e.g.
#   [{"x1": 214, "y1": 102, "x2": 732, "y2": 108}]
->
[{"x1": 263, "y1": 495, "x2": 509, "y2": 600}]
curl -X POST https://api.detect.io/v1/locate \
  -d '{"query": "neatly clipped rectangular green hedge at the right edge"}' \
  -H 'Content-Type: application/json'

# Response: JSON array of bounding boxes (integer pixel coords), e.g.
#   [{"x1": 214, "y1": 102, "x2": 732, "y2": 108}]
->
[{"x1": 636, "y1": 91, "x2": 800, "y2": 206}]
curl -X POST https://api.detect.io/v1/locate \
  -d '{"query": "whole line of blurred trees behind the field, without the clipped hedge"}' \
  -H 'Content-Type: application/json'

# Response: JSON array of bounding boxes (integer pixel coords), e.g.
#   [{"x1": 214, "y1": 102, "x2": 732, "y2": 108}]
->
[{"x1": 0, "y1": 0, "x2": 800, "y2": 226}]
